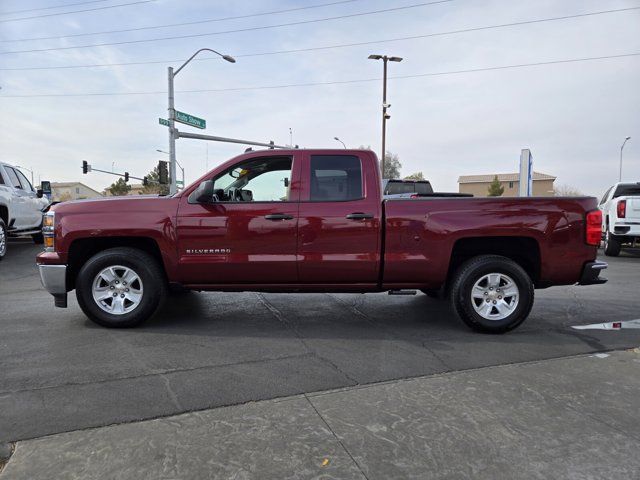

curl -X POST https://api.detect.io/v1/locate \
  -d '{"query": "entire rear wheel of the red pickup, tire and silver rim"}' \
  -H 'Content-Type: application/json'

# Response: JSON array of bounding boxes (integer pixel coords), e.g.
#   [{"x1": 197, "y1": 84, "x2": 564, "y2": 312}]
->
[{"x1": 451, "y1": 255, "x2": 534, "y2": 333}]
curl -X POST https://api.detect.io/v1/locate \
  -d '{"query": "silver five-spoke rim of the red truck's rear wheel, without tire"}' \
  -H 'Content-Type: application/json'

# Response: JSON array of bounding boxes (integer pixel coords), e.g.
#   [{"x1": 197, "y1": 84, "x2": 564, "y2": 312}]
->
[{"x1": 471, "y1": 273, "x2": 520, "y2": 320}]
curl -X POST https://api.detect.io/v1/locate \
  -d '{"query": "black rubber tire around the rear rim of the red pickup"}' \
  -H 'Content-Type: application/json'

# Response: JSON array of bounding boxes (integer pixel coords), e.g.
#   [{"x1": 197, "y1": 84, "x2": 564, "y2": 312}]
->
[{"x1": 451, "y1": 255, "x2": 534, "y2": 333}]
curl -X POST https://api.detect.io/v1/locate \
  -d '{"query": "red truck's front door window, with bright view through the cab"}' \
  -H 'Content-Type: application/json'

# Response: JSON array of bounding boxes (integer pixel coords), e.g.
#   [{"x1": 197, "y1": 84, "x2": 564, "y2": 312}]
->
[{"x1": 213, "y1": 157, "x2": 292, "y2": 202}]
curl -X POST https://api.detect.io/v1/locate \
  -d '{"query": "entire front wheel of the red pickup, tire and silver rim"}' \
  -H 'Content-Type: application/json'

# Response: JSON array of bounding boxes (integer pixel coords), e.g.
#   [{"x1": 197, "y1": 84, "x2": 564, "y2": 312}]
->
[{"x1": 76, "y1": 247, "x2": 167, "y2": 328}]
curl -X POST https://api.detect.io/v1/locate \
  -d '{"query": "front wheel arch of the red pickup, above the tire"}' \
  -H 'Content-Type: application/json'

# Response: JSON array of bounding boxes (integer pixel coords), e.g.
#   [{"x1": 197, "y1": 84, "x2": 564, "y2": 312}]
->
[{"x1": 67, "y1": 237, "x2": 166, "y2": 289}]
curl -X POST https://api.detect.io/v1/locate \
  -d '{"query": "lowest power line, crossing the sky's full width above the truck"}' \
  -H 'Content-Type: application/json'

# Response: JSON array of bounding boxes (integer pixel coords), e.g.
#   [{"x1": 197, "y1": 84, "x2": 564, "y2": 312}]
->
[{"x1": 0, "y1": 52, "x2": 640, "y2": 99}]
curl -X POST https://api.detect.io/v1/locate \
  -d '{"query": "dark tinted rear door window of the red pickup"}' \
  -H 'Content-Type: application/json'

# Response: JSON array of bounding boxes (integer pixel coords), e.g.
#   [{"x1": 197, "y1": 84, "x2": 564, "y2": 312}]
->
[{"x1": 309, "y1": 155, "x2": 362, "y2": 202}]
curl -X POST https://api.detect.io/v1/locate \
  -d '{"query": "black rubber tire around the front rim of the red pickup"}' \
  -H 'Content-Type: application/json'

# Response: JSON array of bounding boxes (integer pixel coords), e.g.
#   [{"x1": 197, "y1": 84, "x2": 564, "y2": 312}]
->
[{"x1": 75, "y1": 247, "x2": 167, "y2": 328}]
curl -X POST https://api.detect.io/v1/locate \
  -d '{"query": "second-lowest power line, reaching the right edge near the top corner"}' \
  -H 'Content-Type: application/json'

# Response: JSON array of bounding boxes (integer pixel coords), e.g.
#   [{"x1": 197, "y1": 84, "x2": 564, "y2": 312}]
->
[{"x1": 0, "y1": 7, "x2": 640, "y2": 71}]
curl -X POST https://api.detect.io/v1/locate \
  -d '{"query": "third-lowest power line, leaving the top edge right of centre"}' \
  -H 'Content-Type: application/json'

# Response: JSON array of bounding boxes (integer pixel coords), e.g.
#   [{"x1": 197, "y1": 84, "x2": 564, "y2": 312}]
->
[{"x1": 0, "y1": 0, "x2": 455, "y2": 55}]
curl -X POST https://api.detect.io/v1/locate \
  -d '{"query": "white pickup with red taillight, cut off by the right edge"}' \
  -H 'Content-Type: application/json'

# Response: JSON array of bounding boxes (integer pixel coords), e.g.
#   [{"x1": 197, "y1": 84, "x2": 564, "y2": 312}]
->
[{"x1": 600, "y1": 182, "x2": 640, "y2": 257}]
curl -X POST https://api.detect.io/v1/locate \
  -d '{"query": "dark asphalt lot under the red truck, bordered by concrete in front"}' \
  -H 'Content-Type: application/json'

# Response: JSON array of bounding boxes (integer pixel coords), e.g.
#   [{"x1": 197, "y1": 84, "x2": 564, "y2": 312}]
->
[{"x1": 0, "y1": 242, "x2": 640, "y2": 442}]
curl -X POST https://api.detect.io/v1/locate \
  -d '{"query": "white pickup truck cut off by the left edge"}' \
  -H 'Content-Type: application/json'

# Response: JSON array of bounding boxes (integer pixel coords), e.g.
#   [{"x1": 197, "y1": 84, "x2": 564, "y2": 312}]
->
[{"x1": 0, "y1": 162, "x2": 49, "y2": 260}]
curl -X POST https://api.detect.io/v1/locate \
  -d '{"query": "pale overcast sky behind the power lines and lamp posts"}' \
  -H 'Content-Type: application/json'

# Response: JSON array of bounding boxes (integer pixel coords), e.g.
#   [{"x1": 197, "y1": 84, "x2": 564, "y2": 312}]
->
[{"x1": 0, "y1": 0, "x2": 640, "y2": 196}]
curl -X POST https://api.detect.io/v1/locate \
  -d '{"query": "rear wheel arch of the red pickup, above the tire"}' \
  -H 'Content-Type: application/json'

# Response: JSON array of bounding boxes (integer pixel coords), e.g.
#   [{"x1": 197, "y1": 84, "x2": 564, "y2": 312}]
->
[{"x1": 447, "y1": 237, "x2": 540, "y2": 284}]
